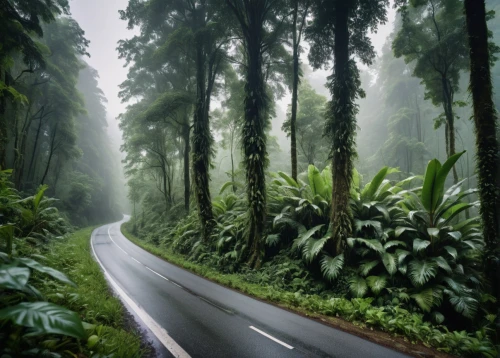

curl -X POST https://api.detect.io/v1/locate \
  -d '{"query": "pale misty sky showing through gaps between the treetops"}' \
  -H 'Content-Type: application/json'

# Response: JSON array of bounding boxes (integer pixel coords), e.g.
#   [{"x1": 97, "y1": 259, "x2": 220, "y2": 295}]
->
[{"x1": 70, "y1": 0, "x2": 395, "y2": 128}]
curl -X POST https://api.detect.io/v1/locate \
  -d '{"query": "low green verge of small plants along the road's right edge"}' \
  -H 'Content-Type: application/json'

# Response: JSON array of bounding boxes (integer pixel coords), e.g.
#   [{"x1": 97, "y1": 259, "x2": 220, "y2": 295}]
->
[{"x1": 121, "y1": 224, "x2": 497, "y2": 358}]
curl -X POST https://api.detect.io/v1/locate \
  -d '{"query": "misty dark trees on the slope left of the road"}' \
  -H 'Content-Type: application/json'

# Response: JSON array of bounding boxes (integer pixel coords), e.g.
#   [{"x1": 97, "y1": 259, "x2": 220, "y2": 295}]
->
[{"x1": 0, "y1": 0, "x2": 120, "y2": 225}]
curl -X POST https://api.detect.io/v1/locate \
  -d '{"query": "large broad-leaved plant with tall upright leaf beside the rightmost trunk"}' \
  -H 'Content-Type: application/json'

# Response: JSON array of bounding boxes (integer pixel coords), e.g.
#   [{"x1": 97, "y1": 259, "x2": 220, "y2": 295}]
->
[{"x1": 395, "y1": 153, "x2": 484, "y2": 318}]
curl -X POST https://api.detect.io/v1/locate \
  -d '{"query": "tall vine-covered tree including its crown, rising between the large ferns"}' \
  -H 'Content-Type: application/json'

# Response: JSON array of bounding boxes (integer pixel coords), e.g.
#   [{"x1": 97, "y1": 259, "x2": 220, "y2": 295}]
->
[{"x1": 307, "y1": 0, "x2": 389, "y2": 254}]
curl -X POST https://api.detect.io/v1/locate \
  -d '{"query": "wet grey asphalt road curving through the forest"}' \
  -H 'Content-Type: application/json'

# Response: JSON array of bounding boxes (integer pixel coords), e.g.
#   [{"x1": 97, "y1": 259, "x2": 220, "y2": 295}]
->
[{"x1": 91, "y1": 220, "x2": 405, "y2": 358}]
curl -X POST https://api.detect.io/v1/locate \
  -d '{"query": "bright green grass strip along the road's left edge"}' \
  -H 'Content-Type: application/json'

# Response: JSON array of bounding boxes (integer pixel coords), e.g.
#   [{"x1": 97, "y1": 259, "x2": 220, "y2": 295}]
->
[{"x1": 43, "y1": 228, "x2": 146, "y2": 358}]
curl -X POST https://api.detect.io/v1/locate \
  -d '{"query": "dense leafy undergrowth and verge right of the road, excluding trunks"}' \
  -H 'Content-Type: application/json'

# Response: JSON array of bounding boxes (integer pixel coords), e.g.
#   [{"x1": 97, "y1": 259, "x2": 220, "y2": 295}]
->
[{"x1": 126, "y1": 153, "x2": 497, "y2": 357}]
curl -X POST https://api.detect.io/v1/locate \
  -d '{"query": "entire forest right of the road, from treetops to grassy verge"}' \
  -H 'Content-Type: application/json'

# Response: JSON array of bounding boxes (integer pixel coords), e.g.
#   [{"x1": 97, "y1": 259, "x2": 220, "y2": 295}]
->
[{"x1": 118, "y1": 0, "x2": 500, "y2": 357}]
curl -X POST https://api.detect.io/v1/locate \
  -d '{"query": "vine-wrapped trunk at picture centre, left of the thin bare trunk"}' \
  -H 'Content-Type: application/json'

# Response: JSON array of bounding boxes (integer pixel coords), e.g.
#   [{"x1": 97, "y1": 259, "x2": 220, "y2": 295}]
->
[{"x1": 242, "y1": 32, "x2": 267, "y2": 268}]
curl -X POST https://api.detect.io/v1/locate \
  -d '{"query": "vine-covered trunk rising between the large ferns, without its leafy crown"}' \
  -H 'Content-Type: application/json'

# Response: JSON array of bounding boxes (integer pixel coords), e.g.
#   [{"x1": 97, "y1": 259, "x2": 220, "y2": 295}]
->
[{"x1": 327, "y1": 0, "x2": 356, "y2": 255}]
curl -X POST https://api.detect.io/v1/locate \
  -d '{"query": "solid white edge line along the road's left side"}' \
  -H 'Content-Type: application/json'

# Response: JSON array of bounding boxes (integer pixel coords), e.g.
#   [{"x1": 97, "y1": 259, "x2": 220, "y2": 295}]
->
[{"x1": 90, "y1": 229, "x2": 191, "y2": 358}]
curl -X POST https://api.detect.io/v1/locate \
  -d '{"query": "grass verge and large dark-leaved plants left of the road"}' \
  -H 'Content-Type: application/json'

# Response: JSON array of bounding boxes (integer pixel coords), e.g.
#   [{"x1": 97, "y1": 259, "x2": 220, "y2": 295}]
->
[{"x1": 0, "y1": 171, "x2": 145, "y2": 357}]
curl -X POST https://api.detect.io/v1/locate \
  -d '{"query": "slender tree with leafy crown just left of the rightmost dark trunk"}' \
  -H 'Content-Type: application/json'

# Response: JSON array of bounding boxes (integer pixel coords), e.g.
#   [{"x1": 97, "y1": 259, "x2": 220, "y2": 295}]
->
[{"x1": 393, "y1": 0, "x2": 469, "y2": 182}]
